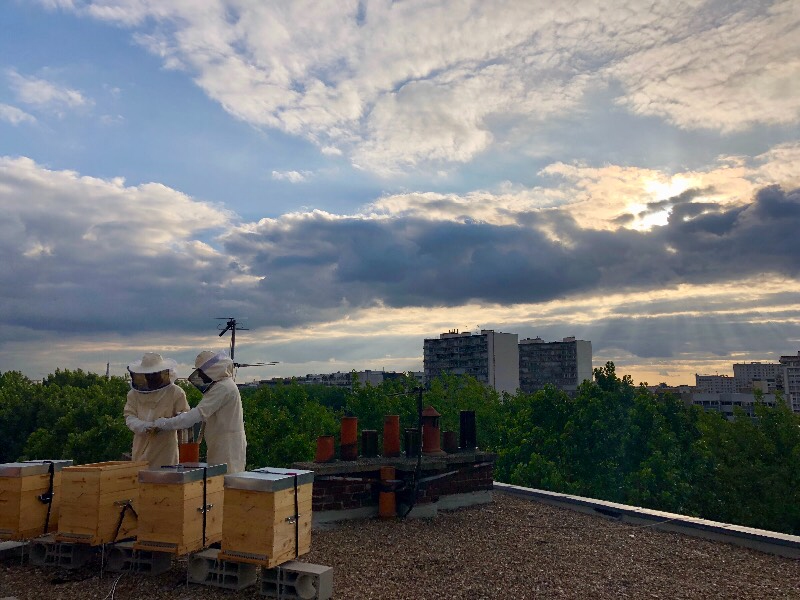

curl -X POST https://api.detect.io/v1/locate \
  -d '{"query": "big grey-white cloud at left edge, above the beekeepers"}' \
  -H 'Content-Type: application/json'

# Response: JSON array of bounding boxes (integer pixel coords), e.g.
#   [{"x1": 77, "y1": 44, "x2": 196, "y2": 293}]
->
[{"x1": 0, "y1": 158, "x2": 238, "y2": 333}]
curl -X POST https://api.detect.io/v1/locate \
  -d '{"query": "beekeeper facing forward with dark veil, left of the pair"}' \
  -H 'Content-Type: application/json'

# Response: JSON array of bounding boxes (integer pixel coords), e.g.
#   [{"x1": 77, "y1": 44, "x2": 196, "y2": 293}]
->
[{"x1": 123, "y1": 352, "x2": 189, "y2": 468}]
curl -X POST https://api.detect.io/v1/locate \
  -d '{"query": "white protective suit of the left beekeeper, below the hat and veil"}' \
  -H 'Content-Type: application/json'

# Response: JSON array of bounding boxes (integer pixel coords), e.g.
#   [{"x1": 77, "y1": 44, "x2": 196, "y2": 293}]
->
[{"x1": 123, "y1": 383, "x2": 189, "y2": 468}]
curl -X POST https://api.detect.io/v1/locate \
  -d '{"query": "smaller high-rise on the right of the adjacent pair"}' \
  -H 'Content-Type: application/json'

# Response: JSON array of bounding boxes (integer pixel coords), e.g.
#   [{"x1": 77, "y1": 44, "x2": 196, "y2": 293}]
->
[{"x1": 519, "y1": 337, "x2": 592, "y2": 393}]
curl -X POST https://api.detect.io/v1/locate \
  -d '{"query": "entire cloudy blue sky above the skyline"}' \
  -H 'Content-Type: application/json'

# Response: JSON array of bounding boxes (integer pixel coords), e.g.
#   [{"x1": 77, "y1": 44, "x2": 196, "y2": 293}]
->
[{"x1": 0, "y1": 0, "x2": 800, "y2": 384}]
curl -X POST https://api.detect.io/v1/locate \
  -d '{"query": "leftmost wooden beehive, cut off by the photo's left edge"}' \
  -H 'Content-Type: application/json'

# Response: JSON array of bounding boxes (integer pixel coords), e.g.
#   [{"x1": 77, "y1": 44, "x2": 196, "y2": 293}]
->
[{"x1": 0, "y1": 460, "x2": 72, "y2": 540}]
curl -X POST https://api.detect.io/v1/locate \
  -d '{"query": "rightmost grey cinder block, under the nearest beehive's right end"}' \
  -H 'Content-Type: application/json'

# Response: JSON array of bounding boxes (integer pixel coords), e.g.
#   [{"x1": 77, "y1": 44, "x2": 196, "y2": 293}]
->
[{"x1": 260, "y1": 560, "x2": 333, "y2": 600}]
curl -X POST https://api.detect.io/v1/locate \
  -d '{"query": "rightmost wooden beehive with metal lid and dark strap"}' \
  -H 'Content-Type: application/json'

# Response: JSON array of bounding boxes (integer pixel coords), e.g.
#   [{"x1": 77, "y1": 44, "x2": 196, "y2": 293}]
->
[{"x1": 219, "y1": 467, "x2": 314, "y2": 568}]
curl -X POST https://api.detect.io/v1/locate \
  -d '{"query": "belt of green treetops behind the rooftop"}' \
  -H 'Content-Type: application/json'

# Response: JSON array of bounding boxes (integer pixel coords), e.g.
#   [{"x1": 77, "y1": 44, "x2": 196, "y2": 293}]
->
[{"x1": 0, "y1": 363, "x2": 800, "y2": 533}]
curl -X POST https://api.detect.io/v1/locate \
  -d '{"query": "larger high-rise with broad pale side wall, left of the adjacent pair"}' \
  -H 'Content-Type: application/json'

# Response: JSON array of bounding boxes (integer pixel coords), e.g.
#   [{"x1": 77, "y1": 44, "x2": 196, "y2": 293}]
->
[{"x1": 423, "y1": 329, "x2": 519, "y2": 394}]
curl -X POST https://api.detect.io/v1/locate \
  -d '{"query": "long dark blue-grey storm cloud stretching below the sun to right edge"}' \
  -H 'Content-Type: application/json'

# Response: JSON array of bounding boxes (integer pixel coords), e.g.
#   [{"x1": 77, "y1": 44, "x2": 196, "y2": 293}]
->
[{"x1": 220, "y1": 186, "x2": 800, "y2": 324}]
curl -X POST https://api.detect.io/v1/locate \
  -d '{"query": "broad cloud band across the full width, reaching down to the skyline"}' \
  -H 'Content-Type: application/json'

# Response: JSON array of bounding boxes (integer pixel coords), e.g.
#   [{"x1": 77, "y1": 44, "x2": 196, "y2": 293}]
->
[{"x1": 0, "y1": 155, "x2": 800, "y2": 376}]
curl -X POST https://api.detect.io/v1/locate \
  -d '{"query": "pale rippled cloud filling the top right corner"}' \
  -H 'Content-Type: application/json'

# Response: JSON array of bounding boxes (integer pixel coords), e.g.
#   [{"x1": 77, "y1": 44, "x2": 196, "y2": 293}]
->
[{"x1": 608, "y1": 0, "x2": 800, "y2": 132}]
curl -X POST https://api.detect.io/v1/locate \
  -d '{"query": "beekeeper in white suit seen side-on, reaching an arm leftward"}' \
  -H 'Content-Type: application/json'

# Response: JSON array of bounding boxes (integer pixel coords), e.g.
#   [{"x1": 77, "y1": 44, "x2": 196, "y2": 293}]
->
[{"x1": 155, "y1": 350, "x2": 247, "y2": 473}]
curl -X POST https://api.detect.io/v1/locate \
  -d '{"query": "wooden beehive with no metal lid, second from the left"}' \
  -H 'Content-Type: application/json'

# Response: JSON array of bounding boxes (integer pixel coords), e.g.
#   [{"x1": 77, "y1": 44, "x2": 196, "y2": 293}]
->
[{"x1": 56, "y1": 460, "x2": 147, "y2": 546}]
